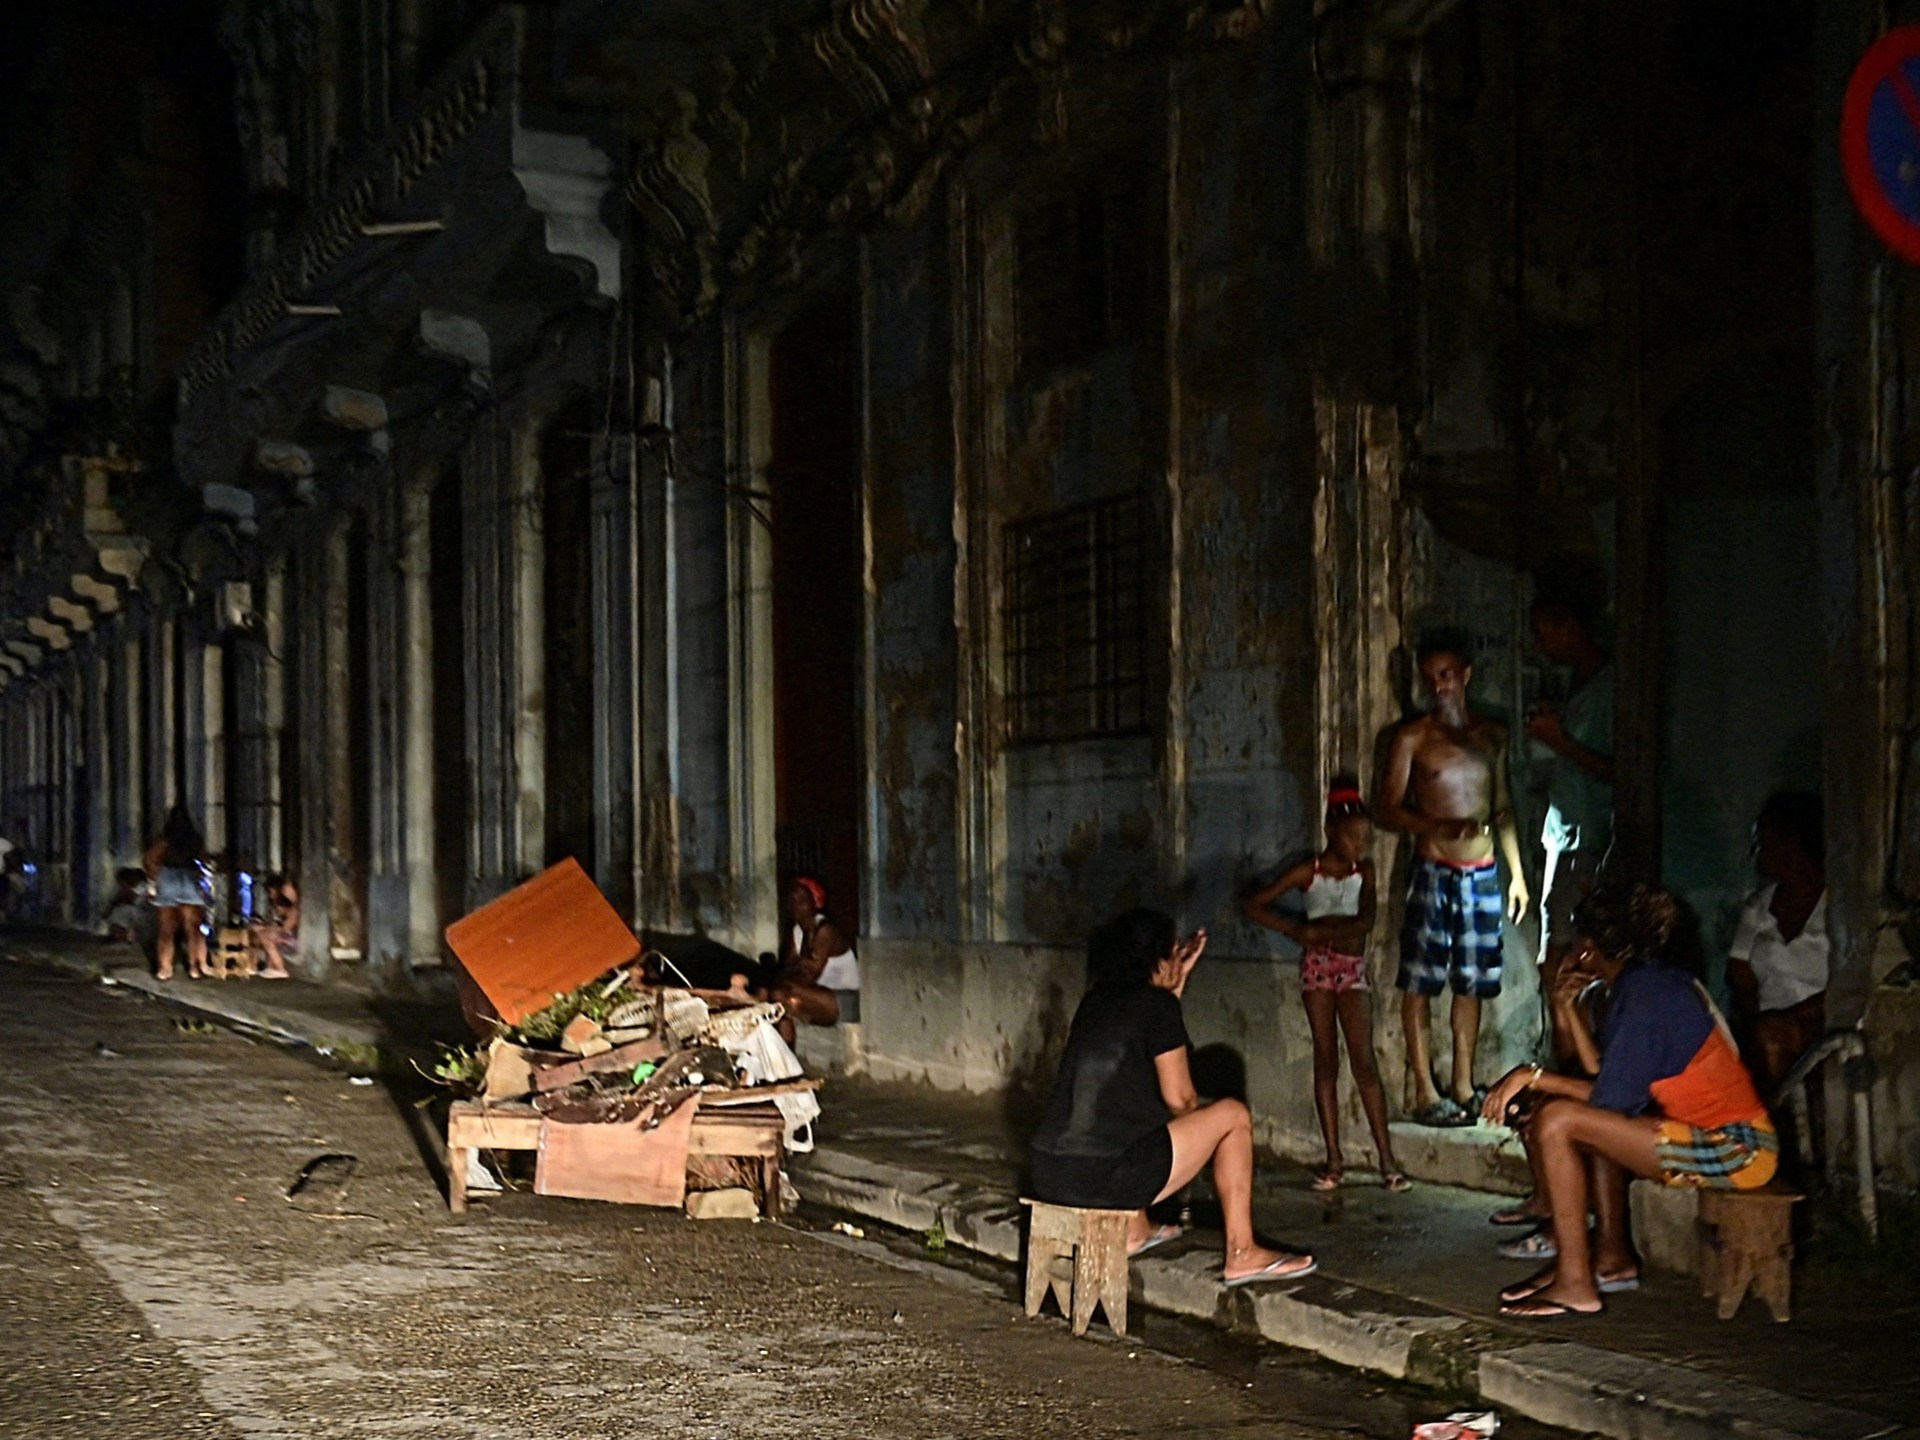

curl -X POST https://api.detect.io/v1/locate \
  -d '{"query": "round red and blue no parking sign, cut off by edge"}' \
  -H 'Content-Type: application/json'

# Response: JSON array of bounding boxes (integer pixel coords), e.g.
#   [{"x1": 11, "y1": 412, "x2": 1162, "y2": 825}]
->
[{"x1": 1839, "y1": 25, "x2": 1920, "y2": 265}]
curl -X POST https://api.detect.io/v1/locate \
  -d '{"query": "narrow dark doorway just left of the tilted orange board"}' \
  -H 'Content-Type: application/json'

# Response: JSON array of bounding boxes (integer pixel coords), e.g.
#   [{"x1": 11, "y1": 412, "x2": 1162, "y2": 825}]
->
[{"x1": 426, "y1": 465, "x2": 472, "y2": 931}]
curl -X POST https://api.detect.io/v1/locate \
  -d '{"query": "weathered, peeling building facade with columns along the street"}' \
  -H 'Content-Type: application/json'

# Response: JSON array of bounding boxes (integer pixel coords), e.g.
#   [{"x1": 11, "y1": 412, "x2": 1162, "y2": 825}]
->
[{"x1": 0, "y1": 0, "x2": 1920, "y2": 1185}]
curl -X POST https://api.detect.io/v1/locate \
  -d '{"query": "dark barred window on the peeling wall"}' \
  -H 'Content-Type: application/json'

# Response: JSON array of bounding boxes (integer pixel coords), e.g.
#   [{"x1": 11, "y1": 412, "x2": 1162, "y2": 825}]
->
[{"x1": 1006, "y1": 493, "x2": 1150, "y2": 745}]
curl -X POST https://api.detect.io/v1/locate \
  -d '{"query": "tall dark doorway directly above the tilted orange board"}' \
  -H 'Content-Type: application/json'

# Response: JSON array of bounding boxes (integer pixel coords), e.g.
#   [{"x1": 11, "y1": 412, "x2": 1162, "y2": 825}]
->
[{"x1": 540, "y1": 399, "x2": 601, "y2": 879}]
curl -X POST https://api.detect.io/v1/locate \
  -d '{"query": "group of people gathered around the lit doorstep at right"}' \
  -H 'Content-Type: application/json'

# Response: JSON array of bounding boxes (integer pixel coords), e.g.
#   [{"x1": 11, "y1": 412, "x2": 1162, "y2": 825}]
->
[{"x1": 1029, "y1": 595, "x2": 1828, "y2": 1319}]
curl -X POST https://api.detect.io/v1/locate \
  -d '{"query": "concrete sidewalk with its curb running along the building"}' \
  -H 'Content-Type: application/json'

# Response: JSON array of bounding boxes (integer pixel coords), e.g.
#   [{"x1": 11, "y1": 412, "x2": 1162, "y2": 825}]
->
[{"x1": 0, "y1": 937, "x2": 1920, "y2": 1440}]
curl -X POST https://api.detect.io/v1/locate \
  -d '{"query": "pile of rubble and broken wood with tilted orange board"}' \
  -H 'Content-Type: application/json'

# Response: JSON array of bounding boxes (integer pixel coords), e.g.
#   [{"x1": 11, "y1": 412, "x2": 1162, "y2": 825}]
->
[{"x1": 434, "y1": 860, "x2": 820, "y2": 1215}]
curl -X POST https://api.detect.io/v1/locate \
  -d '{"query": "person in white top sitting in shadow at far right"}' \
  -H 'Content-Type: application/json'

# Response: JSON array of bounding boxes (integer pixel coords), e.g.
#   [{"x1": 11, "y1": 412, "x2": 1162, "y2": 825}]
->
[{"x1": 1726, "y1": 791, "x2": 1830, "y2": 1094}]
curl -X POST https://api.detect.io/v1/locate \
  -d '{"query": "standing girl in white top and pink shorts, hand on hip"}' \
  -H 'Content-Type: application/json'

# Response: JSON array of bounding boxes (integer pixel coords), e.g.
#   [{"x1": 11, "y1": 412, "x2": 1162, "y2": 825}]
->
[{"x1": 1246, "y1": 781, "x2": 1411, "y2": 1190}]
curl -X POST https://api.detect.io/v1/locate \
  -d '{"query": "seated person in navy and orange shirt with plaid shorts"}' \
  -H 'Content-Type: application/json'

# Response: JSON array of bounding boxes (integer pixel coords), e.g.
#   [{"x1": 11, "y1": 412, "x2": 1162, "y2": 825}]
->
[{"x1": 1482, "y1": 883, "x2": 1780, "y2": 1319}]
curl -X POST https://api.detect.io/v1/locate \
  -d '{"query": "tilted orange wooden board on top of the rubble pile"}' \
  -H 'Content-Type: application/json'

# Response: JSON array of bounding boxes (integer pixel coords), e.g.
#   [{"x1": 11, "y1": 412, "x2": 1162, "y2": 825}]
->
[{"x1": 447, "y1": 858, "x2": 639, "y2": 1025}]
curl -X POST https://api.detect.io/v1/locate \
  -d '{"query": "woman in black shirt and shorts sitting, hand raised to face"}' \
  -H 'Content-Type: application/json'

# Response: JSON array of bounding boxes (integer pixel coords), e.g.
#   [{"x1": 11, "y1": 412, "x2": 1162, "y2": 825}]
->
[{"x1": 1029, "y1": 910, "x2": 1313, "y2": 1284}]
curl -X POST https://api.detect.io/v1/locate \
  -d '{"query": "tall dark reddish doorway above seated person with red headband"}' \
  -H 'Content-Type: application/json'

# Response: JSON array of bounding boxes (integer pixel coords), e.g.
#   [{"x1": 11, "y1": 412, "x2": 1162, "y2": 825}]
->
[{"x1": 768, "y1": 294, "x2": 866, "y2": 927}]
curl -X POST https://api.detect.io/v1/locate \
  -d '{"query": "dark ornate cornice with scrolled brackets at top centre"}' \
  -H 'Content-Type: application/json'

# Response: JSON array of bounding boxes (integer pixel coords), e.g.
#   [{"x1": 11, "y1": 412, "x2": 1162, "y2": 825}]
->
[{"x1": 628, "y1": 0, "x2": 1267, "y2": 319}]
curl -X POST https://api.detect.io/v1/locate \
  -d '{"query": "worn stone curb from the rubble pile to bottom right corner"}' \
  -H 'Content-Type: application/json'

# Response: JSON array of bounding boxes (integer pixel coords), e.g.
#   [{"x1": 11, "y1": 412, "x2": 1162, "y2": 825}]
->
[{"x1": 793, "y1": 1144, "x2": 1920, "y2": 1440}]
